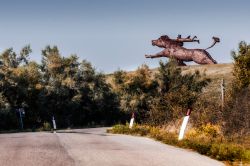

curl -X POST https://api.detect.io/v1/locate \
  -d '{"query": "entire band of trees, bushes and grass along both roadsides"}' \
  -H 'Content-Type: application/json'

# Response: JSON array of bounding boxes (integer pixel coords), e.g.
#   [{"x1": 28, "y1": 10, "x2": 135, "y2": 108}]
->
[{"x1": 0, "y1": 42, "x2": 250, "y2": 163}]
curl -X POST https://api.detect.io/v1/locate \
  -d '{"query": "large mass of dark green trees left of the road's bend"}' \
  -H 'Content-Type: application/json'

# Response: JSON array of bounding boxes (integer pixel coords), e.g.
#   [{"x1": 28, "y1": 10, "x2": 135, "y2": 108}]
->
[{"x1": 0, "y1": 46, "x2": 127, "y2": 130}]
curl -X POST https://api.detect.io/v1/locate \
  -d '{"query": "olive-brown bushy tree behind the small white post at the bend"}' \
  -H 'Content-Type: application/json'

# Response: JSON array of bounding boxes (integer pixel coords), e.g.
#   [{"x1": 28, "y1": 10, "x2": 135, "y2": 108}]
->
[{"x1": 113, "y1": 65, "x2": 157, "y2": 123}]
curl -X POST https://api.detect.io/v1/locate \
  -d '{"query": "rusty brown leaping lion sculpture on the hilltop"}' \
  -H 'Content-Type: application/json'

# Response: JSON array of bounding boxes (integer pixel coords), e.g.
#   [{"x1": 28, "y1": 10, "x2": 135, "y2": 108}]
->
[{"x1": 145, "y1": 35, "x2": 220, "y2": 66}]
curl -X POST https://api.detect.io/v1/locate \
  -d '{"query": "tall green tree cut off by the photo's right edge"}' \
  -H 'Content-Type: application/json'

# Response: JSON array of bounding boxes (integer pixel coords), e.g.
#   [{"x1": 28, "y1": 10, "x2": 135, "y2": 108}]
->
[{"x1": 223, "y1": 41, "x2": 250, "y2": 135}]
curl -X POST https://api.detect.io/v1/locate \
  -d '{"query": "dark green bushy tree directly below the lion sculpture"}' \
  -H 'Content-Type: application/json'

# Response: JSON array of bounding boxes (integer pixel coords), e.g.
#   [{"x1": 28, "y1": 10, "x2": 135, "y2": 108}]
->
[{"x1": 149, "y1": 60, "x2": 210, "y2": 125}]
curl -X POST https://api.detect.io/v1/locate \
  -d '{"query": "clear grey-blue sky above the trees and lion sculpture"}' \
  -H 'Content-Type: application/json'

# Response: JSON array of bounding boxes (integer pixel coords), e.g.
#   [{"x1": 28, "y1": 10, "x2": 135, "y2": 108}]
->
[{"x1": 0, "y1": 0, "x2": 250, "y2": 73}]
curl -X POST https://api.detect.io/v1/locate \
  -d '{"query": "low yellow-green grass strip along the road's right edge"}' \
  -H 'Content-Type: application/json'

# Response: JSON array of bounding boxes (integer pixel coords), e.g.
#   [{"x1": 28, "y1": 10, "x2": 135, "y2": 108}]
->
[{"x1": 108, "y1": 124, "x2": 250, "y2": 164}]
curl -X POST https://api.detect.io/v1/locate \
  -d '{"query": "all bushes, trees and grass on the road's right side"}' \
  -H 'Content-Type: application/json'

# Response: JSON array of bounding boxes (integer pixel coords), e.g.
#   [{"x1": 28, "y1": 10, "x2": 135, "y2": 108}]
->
[{"x1": 109, "y1": 42, "x2": 250, "y2": 165}]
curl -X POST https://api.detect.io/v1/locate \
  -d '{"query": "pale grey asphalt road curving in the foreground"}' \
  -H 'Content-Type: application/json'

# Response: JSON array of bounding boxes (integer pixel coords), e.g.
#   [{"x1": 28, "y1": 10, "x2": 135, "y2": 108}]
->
[{"x1": 0, "y1": 128, "x2": 223, "y2": 166}]
